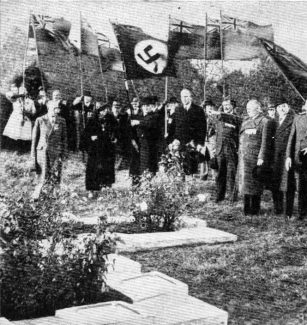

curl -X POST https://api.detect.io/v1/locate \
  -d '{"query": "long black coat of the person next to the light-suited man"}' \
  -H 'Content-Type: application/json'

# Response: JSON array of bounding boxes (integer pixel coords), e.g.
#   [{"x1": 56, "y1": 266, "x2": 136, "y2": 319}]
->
[{"x1": 80, "y1": 113, "x2": 117, "y2": 191}]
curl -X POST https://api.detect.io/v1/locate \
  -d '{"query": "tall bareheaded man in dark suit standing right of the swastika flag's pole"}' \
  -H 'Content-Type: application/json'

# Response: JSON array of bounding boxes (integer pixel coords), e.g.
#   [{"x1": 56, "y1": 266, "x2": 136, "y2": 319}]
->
[{"x1": 172, "y1": 89, "x2": 207, "y2": 174}]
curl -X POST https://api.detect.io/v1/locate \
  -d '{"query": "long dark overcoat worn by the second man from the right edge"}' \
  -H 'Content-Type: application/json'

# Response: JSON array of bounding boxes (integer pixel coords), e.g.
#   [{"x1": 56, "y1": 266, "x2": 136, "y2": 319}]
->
[{"x1": 271, "y1": 110, "x2": 295, "y2": 192}]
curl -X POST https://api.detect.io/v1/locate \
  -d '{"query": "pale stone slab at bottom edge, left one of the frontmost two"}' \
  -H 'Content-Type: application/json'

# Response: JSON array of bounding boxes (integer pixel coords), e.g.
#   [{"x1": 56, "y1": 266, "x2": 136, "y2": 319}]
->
[{"x1": 56, "y1": 301, "x2": 154, "y2": 325}]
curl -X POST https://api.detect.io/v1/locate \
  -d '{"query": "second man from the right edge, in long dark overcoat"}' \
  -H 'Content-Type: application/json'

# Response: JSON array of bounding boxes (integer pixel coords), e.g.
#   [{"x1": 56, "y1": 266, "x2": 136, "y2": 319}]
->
[{"x1": 271, "y1": 103, "x2": 295, "y2": 217}]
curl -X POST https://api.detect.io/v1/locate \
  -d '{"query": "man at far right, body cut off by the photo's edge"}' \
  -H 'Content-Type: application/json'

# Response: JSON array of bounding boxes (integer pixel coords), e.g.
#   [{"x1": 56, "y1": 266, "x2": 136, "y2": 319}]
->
[{"x1": 286, "y1": 102, "x2": 307, "y2": 219}]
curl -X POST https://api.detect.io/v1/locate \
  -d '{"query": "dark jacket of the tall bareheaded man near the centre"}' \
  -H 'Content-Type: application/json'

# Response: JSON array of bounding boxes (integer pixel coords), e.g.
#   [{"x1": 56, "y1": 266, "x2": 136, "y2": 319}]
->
[{"x1": 173, "y1": 103, "x2": 207, "y2": 145}]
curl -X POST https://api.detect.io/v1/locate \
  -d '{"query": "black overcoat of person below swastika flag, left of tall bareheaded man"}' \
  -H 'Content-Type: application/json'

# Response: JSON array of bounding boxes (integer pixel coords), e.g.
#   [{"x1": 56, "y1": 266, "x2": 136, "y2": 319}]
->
[{"x1": 137, "y1": 113, "x2": 159, "y2": 175}]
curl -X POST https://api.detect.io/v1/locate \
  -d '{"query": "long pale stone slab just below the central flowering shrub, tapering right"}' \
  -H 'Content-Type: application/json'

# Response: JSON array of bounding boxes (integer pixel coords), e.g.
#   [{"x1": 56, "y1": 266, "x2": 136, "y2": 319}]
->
[{"x1": 117, "y1": 227, "x2": 237, "y2": 252}]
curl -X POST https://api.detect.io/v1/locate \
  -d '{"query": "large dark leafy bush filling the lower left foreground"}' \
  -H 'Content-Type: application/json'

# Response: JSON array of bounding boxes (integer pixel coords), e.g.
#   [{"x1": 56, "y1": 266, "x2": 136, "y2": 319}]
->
[{"x1": 0, "y1": 181, "x2": 116, "y2": 319}]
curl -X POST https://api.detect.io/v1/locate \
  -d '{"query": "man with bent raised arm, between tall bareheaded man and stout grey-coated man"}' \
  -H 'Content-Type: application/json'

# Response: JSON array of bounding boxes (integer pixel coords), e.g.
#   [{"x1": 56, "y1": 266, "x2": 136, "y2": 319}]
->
[{"x1": 212, "y1": 99, "x2": 242, "y2": 202}]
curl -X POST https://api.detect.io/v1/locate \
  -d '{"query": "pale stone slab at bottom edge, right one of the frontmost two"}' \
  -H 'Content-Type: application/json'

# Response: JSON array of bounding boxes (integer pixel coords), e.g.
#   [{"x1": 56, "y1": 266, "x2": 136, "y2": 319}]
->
[{"x1": 135, "y1": 296, "x2": 228, "y2": 325}]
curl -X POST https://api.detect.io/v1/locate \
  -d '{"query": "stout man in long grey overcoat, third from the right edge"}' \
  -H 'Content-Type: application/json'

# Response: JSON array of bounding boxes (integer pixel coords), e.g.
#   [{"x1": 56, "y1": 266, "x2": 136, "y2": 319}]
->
[{"x1": 237, "y1": 99, "x2": 272, "y2": 215}]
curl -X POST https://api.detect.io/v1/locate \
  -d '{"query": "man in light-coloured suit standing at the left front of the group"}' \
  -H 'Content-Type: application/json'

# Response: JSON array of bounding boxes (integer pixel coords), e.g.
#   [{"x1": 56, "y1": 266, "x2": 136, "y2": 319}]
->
[{"x1": 31, "y1": 103, "x2": 67, "y2": 199}]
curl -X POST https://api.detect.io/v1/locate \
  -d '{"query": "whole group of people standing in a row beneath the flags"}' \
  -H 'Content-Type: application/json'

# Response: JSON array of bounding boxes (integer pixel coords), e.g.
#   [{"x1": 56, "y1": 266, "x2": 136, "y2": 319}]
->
[{"x1": 3, "y1": 85, "x2": 307, "y2": 218}]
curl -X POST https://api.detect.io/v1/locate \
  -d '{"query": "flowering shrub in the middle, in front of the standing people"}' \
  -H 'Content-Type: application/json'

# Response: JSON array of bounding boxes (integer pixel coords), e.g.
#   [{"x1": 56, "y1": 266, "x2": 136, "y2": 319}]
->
[{"x1": 131, "y1": 154, "x2": 189, "y2": 232}]
